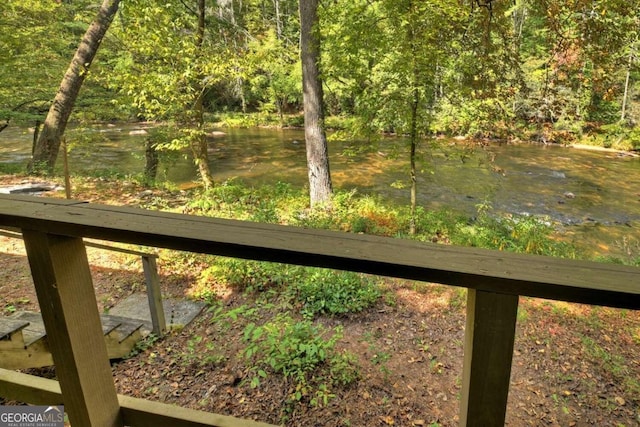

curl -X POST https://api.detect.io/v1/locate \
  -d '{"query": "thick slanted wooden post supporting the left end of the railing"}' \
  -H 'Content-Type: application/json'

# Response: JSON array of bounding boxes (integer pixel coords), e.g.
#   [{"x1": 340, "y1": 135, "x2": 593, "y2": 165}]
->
[{"x1": 23, "y1": 230, "x2": 123, "y2": 427}]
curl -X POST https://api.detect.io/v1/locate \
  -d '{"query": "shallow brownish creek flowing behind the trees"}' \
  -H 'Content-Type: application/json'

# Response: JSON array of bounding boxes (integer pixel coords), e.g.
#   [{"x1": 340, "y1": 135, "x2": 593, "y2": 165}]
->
[{"x1": 0, "y1": 124, "x2": 640, "y2": 257}]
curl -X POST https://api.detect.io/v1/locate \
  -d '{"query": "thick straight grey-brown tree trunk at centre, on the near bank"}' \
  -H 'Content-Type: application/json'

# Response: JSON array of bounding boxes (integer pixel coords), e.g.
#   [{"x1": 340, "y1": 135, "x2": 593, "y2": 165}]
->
[{"x1": 299, "y1": 0, "x2": 333, "y2": 207}]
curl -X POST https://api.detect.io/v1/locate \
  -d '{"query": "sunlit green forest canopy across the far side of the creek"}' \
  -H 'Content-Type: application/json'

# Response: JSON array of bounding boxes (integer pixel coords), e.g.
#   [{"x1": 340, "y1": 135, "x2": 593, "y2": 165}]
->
[{"x1": 0, "y1": 0, "x2": 640, "y2": 149}]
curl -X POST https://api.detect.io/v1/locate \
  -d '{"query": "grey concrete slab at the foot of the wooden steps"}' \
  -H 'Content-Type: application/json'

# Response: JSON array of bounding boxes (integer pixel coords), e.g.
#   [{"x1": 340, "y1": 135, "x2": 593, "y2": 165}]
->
[{"x1": 109, "y1": 292, "x2": 206, "y2": 336}]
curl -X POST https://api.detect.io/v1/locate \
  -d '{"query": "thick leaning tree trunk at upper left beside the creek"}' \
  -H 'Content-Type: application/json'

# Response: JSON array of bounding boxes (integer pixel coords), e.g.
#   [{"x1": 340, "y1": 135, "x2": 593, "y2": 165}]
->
[{"x1": 27, "y1": 0, "x2": 120, "y2": 174}]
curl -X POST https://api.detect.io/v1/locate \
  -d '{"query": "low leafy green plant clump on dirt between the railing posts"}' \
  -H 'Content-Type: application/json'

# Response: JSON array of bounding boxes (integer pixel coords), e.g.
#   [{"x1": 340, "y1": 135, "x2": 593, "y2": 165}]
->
[{"x1": 243, "y1": 315, "x2": 358, "y2": 406}]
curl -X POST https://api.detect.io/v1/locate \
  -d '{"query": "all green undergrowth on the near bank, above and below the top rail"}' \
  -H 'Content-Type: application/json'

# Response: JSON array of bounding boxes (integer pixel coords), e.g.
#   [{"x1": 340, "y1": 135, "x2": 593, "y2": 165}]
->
[{"x1": 172, "y1": 180, "x2": 576, "y2": 411}]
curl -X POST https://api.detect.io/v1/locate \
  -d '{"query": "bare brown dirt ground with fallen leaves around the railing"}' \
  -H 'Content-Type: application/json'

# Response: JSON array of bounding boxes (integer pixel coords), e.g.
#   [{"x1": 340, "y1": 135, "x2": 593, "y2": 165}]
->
[{"x1": 0, "y1": 176, "x2": 640, "y2": 427}]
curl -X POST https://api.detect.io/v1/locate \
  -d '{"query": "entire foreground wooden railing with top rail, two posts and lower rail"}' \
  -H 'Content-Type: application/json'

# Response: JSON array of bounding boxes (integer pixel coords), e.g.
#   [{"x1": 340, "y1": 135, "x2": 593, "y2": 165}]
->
[{"x1": 0, "y1": 195, "x2": 640, "y2": 427}]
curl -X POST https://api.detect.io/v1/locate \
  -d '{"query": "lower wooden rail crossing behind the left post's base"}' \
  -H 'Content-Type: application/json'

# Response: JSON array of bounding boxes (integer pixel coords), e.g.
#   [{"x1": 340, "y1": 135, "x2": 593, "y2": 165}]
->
[{"x1": 0, "y1": 369, "x2": 275, "y2": 427}]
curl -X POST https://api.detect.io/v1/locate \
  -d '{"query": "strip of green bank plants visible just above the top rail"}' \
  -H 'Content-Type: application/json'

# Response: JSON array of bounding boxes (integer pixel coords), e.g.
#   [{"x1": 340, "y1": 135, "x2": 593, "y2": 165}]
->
[{"x1": 187, "y1": 180, "x2": 576, "y2": 258}]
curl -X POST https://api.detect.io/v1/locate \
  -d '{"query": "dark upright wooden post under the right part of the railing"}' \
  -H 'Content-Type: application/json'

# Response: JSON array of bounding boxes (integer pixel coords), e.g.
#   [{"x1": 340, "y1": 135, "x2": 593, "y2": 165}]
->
[{"x1": 460, "y1": 289, "x2": 518, "y2": 427}]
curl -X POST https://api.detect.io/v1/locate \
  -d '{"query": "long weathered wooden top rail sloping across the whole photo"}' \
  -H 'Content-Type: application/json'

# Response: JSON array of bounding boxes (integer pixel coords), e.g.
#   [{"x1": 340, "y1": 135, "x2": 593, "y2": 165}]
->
[{"x1": 0, "y1": 195, "x2": 640, "y2": 309}]
